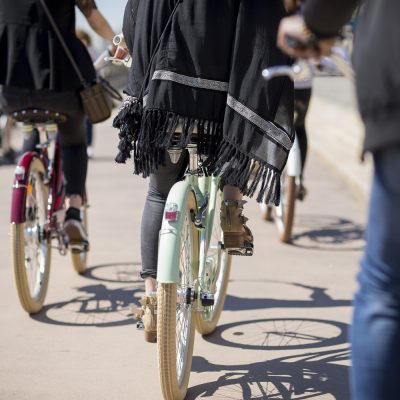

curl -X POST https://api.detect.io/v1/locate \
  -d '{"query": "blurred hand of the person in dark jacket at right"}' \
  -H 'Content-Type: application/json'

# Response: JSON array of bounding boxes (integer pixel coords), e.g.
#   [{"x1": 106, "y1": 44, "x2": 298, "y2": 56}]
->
[{"x1": 277, "y1": 15, "x2": 335, "y2": 58}]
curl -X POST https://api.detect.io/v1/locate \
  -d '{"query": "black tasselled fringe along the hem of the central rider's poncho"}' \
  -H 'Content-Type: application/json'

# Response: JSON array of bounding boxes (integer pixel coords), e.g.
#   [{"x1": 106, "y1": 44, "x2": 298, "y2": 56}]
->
[{"x1": 113, "y1": 97, "x2": 281, "y2": 205}]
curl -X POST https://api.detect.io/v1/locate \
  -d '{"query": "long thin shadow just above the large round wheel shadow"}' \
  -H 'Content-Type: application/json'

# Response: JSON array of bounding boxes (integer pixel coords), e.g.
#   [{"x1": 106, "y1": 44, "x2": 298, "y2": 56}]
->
[{"x1": 224, "y1": 281, "x2": 352, "y2": 311}]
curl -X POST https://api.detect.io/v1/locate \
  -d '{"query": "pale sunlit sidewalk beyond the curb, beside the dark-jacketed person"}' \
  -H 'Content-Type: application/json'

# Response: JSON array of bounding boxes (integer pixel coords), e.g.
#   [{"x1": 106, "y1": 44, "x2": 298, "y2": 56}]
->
[{"x1": 307, "y1": 77, "x2": 372, "y2": 199}]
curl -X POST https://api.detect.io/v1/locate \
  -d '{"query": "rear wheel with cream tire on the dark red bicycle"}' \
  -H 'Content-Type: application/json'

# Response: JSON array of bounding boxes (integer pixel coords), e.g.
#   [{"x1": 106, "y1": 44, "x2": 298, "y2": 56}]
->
[{"x1": 11, "y1": 158, "x2": 51, "y2": 314}]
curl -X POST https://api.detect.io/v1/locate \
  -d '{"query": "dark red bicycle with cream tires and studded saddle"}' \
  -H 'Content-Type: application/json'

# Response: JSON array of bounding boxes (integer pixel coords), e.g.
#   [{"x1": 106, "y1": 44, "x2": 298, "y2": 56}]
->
[{"x1": 10, "y1": 109, "x2": 89, "y2": 313}]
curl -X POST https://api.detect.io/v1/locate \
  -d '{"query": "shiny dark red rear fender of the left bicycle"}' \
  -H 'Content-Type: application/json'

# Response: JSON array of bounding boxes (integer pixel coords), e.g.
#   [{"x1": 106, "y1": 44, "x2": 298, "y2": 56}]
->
[{"x1": 10, "y1": 152, "x2": 45, "y2": 224}]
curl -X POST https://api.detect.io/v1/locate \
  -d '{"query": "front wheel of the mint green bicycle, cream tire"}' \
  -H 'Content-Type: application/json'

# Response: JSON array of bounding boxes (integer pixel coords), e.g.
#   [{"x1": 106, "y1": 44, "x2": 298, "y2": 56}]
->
[{"x1": 195, "y1": 195, "x2": 232, "y2": 335}]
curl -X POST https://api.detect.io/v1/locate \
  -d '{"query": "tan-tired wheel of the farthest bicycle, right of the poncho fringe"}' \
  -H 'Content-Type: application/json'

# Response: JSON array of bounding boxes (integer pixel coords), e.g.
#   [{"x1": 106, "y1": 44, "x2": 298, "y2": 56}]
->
[{"x1": 275, "y1": 176, "x2": 296, "y2": 243}]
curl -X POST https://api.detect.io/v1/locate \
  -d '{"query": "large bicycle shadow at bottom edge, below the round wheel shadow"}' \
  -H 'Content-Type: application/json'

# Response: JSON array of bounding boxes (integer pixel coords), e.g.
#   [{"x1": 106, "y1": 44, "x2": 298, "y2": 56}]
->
[{"x1": 186, "y1": 348, "x2": 350, "y2": 400}]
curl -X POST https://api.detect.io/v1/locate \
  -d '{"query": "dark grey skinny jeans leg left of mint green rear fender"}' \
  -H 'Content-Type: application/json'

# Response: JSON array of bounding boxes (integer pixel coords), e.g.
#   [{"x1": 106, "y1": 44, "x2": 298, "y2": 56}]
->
[{"x1": 140, "y1": 152, "x2": 188, "y2": 278}]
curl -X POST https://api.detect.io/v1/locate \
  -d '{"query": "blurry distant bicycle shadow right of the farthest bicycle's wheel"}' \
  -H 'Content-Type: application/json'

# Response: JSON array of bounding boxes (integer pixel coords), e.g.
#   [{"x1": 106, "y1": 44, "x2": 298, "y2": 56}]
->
[{"x1": 291, "y1": 214, "x2": 365, "y2": 251}]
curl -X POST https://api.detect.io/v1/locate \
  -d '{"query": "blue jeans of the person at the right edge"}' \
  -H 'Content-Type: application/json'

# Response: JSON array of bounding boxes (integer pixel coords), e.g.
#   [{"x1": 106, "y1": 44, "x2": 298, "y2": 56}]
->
[{"x1": 351, "y1": 146, "x2": 400, "y2": 400}]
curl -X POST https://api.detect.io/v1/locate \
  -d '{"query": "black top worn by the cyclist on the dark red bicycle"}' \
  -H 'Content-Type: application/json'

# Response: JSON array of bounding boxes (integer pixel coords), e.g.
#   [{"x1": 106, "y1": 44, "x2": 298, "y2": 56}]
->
[{"x1": 0, "y1": 0, "x2": 96, "y2": 92}]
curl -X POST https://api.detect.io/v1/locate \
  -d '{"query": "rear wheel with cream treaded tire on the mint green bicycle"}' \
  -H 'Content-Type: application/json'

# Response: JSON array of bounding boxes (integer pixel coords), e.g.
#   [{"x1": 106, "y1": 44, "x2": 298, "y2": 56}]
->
[{"x1": 157, "y1": 192, "x2": 198, "y2": 400}]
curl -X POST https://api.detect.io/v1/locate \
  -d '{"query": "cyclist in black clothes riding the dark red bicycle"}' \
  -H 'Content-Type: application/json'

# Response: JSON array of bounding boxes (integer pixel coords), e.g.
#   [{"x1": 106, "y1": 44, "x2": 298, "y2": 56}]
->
[{"x1": 0, "y1": 0, "x2": 114, "y2": 242}]
